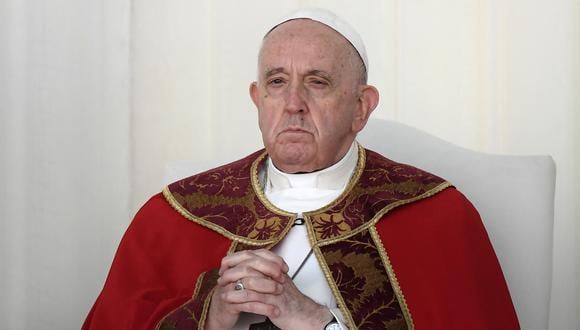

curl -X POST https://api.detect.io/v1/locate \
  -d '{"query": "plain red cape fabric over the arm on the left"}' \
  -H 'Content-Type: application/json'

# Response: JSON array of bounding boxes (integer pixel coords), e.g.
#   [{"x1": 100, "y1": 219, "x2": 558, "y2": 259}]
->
[{"x1": 82, "y1": 194, "x2": 231, "y2": 330}]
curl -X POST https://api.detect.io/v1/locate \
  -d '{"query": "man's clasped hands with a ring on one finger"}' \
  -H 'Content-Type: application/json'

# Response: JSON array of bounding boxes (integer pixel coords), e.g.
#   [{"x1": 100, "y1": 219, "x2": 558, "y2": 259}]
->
[{"x1": 206, "y1": 249, "x2": 332, "y2": 330}]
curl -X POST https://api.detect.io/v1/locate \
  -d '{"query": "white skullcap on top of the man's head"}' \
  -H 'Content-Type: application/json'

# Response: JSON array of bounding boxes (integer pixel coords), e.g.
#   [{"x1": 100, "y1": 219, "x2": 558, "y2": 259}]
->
[{"x1": 266, "y1": 8, "x2": 369, "y2": 72}]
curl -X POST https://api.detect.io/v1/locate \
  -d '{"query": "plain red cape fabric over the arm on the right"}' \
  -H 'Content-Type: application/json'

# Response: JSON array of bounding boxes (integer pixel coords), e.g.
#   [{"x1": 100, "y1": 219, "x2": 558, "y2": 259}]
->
[{"x1": 377, "y1": 189, "x2": 519, "y2": 330}]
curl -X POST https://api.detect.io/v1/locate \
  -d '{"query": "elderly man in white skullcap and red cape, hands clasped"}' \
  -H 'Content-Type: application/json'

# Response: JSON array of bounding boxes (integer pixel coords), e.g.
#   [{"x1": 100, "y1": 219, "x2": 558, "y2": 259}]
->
[{"x1": 83, "y1": 10, "x2": 518, "y2": 329}]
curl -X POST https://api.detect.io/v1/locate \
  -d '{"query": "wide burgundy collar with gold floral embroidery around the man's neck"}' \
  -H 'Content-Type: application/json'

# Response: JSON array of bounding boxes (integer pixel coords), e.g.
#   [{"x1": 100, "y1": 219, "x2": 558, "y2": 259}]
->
[{"x1": 166, "y1": 150, "x2": 445, "y2": 242}]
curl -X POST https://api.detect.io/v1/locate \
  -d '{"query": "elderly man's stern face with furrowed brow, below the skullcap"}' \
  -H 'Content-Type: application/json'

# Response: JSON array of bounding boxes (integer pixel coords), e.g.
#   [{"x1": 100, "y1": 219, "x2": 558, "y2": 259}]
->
[{"x1": 250, "y1": 19, "x2": 374, "y2": 173}]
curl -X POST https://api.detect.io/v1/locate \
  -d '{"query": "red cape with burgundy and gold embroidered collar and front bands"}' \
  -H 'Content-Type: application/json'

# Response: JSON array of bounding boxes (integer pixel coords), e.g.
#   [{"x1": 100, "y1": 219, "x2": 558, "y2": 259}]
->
[{"x1": 83, "y1": 148, "x2": 519, "y2": 329}]
